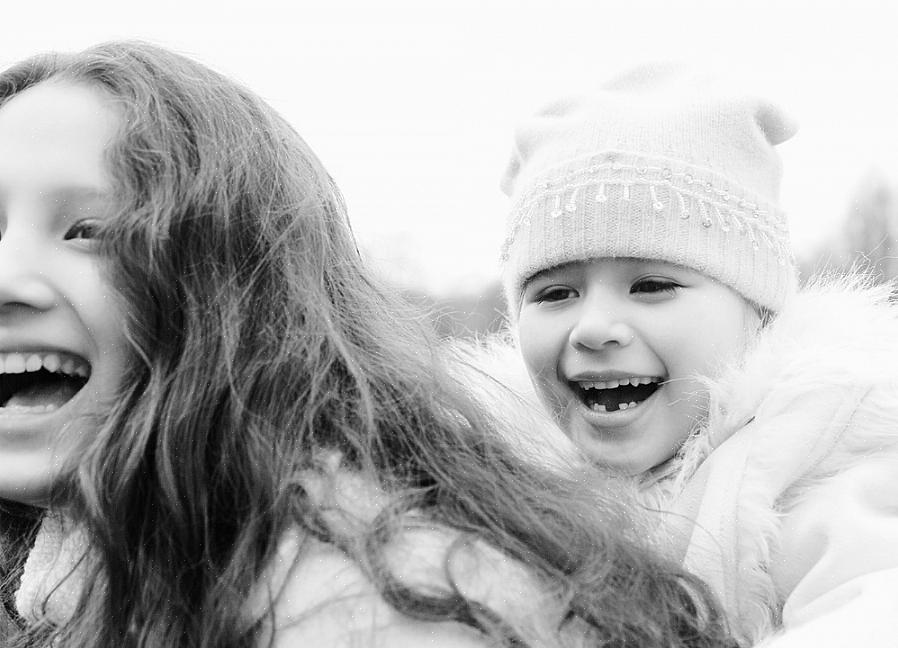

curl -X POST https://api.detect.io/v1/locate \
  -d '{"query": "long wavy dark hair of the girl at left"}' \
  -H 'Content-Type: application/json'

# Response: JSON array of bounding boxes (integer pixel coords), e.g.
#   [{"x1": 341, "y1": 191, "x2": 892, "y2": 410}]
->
[{"x1": 0, "y1": 43, "x2": 726, "y2": 647}]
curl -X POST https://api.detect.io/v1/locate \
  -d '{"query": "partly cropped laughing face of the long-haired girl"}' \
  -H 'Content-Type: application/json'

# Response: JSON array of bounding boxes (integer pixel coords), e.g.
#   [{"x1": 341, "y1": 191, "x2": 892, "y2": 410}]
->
[{"x1": 0, "y1": 81, "x2": 125, "y2": 504}]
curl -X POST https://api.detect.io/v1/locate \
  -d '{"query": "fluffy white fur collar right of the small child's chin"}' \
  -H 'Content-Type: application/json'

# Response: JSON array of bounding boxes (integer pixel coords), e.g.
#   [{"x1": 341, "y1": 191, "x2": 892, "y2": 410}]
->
[{"x1": 665, "y1": 277, "x2": 898, "y2": 484}]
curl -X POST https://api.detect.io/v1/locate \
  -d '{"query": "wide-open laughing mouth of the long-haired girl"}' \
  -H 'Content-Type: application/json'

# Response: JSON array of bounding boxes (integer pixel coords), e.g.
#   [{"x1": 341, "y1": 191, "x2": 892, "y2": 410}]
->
[{"x1": 0, "y1": 352, "x2": 90, "y2": 414}]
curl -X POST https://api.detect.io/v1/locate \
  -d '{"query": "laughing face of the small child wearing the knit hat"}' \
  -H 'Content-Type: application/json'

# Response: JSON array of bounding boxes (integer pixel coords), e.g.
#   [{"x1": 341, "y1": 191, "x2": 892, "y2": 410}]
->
[{"x1": 518, "y1": 259, "x2": 759, "y2": 474}]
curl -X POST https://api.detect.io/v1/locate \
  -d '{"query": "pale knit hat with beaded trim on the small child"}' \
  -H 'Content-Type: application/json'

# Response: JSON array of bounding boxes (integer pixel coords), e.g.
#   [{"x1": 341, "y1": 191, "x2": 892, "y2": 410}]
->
[{"x1": 502, "y1": 67, "x2": 797, "y2": 317}]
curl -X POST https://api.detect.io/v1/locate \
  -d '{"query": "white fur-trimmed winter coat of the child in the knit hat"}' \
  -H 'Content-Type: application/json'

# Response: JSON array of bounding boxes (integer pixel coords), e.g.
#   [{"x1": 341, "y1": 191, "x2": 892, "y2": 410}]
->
[{"x1": 666, "y1": 280, "x2": 898, "y2": 648}]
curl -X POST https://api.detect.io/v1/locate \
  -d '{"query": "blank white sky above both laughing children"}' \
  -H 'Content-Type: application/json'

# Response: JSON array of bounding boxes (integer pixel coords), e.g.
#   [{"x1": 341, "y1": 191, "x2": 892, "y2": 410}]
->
[{"x1": 0, "y1": 0, "x2": 898, "y2": 293}]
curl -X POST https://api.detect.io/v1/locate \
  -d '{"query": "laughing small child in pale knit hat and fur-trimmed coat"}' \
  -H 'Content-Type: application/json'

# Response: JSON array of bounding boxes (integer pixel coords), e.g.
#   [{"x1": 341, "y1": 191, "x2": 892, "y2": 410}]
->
[{"x1": 503, "y1": 67, "x2": 898, "y2": 646}]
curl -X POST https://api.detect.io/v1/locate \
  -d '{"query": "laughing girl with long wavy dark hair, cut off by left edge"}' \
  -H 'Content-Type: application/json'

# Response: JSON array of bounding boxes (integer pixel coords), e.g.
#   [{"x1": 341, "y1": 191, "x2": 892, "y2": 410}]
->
[{"x1": 0, "y1": 43, "x2": 727, "y2": 648}]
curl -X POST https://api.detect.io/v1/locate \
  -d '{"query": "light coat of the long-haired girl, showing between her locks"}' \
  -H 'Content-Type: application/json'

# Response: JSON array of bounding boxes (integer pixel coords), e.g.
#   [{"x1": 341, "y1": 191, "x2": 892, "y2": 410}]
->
[{"x1": 12, "y1": 453, "x2": 591, "y2": 648}]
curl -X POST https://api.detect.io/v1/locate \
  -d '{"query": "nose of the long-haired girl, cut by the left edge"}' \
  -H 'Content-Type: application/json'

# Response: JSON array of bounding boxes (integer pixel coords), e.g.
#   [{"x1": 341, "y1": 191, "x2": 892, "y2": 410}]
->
[{"x1": 0, "y1": 232, "x2": 56, "y2": 317}]
